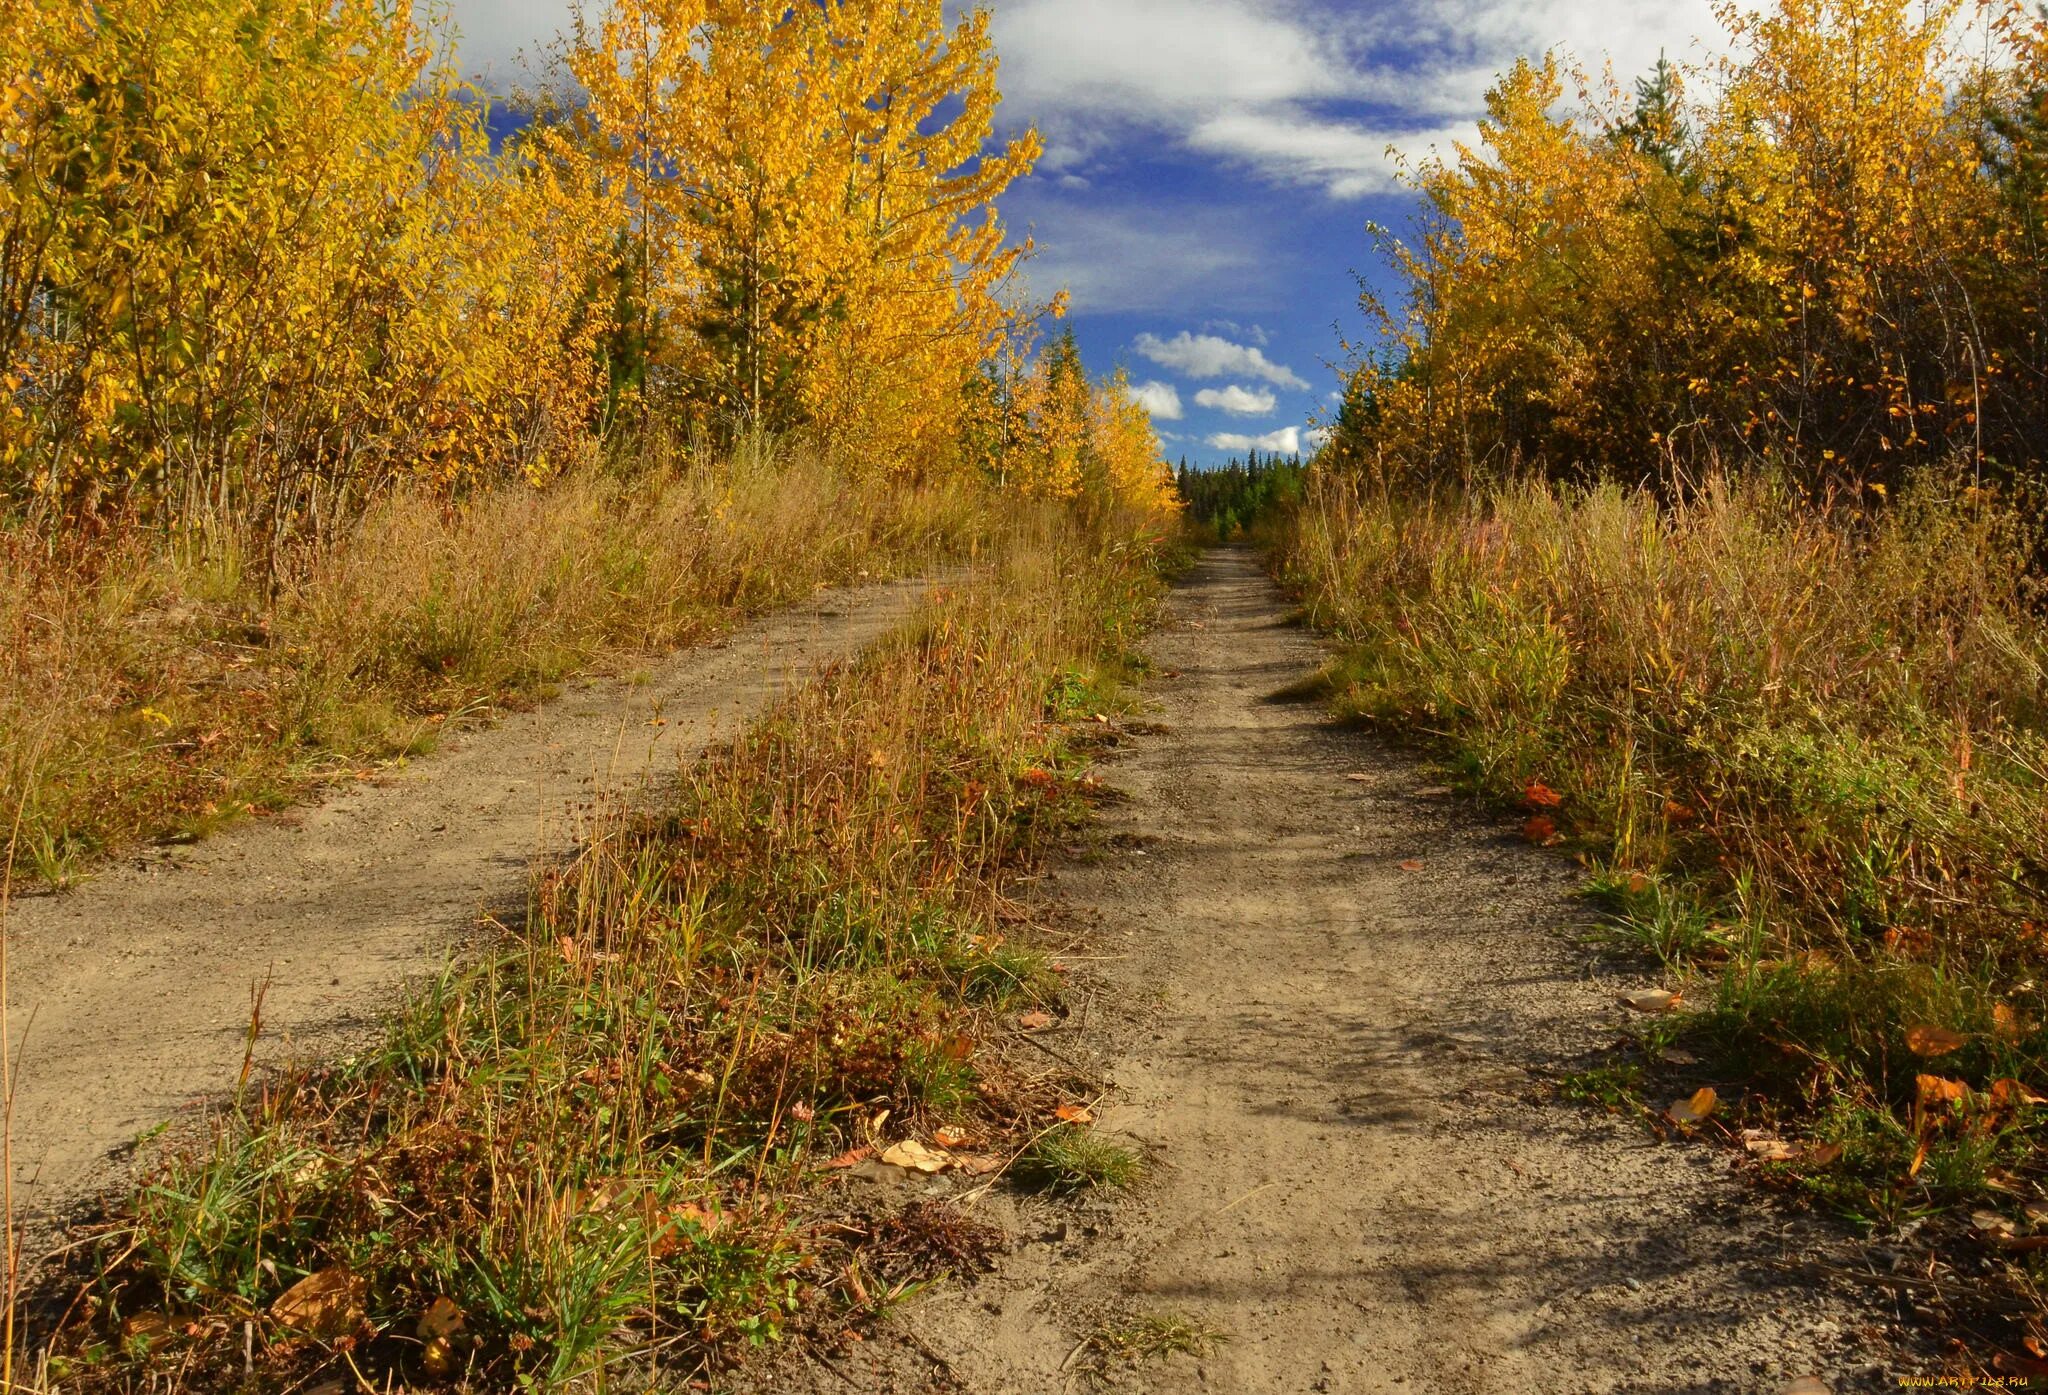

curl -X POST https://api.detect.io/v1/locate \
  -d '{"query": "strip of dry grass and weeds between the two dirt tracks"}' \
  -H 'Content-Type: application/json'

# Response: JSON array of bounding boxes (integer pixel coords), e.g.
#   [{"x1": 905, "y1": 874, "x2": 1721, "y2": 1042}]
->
[{"x1": 51, "y1": 505, "x2": 1155, "y2": 1389}]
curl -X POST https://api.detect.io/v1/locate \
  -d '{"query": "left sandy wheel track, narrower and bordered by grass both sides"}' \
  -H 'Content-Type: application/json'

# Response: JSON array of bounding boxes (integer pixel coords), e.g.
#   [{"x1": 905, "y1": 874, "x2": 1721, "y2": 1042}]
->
[{"x1": 8, "y1": 582, "x2": 924, "y2": 1231}]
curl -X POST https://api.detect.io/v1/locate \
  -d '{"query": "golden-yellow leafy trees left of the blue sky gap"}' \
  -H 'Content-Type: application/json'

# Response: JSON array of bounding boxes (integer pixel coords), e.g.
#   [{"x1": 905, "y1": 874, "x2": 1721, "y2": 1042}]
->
[{"x1": 0, "y1": 0, "x2": 1081, "y2": 551}]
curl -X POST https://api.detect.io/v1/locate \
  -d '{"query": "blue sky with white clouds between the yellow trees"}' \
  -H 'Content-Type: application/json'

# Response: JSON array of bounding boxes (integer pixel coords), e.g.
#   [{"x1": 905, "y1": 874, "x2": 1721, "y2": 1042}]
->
[{"x1": 453, "y1": 0, "x2": 1718, "y2": 463}]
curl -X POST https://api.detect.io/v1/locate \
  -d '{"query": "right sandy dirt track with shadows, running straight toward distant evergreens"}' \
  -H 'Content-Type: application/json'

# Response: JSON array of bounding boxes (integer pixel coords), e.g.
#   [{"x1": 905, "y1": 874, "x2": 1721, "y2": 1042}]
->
[{"x1": 750, "y1": 553, "x2": 1898, "y2": 1395}]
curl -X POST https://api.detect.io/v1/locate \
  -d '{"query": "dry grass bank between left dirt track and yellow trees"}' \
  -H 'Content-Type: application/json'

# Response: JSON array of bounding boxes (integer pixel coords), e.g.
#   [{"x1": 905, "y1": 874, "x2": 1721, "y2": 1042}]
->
[{"x1": 0, "y1": 440, "x2": 989, "y2": 885}]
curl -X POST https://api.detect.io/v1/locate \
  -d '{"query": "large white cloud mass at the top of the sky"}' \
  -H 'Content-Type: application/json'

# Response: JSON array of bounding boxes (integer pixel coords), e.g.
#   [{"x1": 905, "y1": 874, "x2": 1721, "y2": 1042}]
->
[{"x1": 995, "y1": 0, "x2": 1724, "y2": 199}]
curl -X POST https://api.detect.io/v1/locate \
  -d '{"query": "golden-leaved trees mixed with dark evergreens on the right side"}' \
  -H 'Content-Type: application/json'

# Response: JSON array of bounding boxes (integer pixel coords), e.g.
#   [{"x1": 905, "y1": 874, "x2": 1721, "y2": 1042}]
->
[{"x1": 1333, "y1": 0, "x2": 2048, "y2": 492}]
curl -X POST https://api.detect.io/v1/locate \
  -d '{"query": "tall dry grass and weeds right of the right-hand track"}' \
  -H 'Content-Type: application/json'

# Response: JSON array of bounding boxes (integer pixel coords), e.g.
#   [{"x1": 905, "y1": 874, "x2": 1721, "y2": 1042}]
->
[{"x1": 1288, "y1": 479, "x2": 2048, "y2": 1225}]
